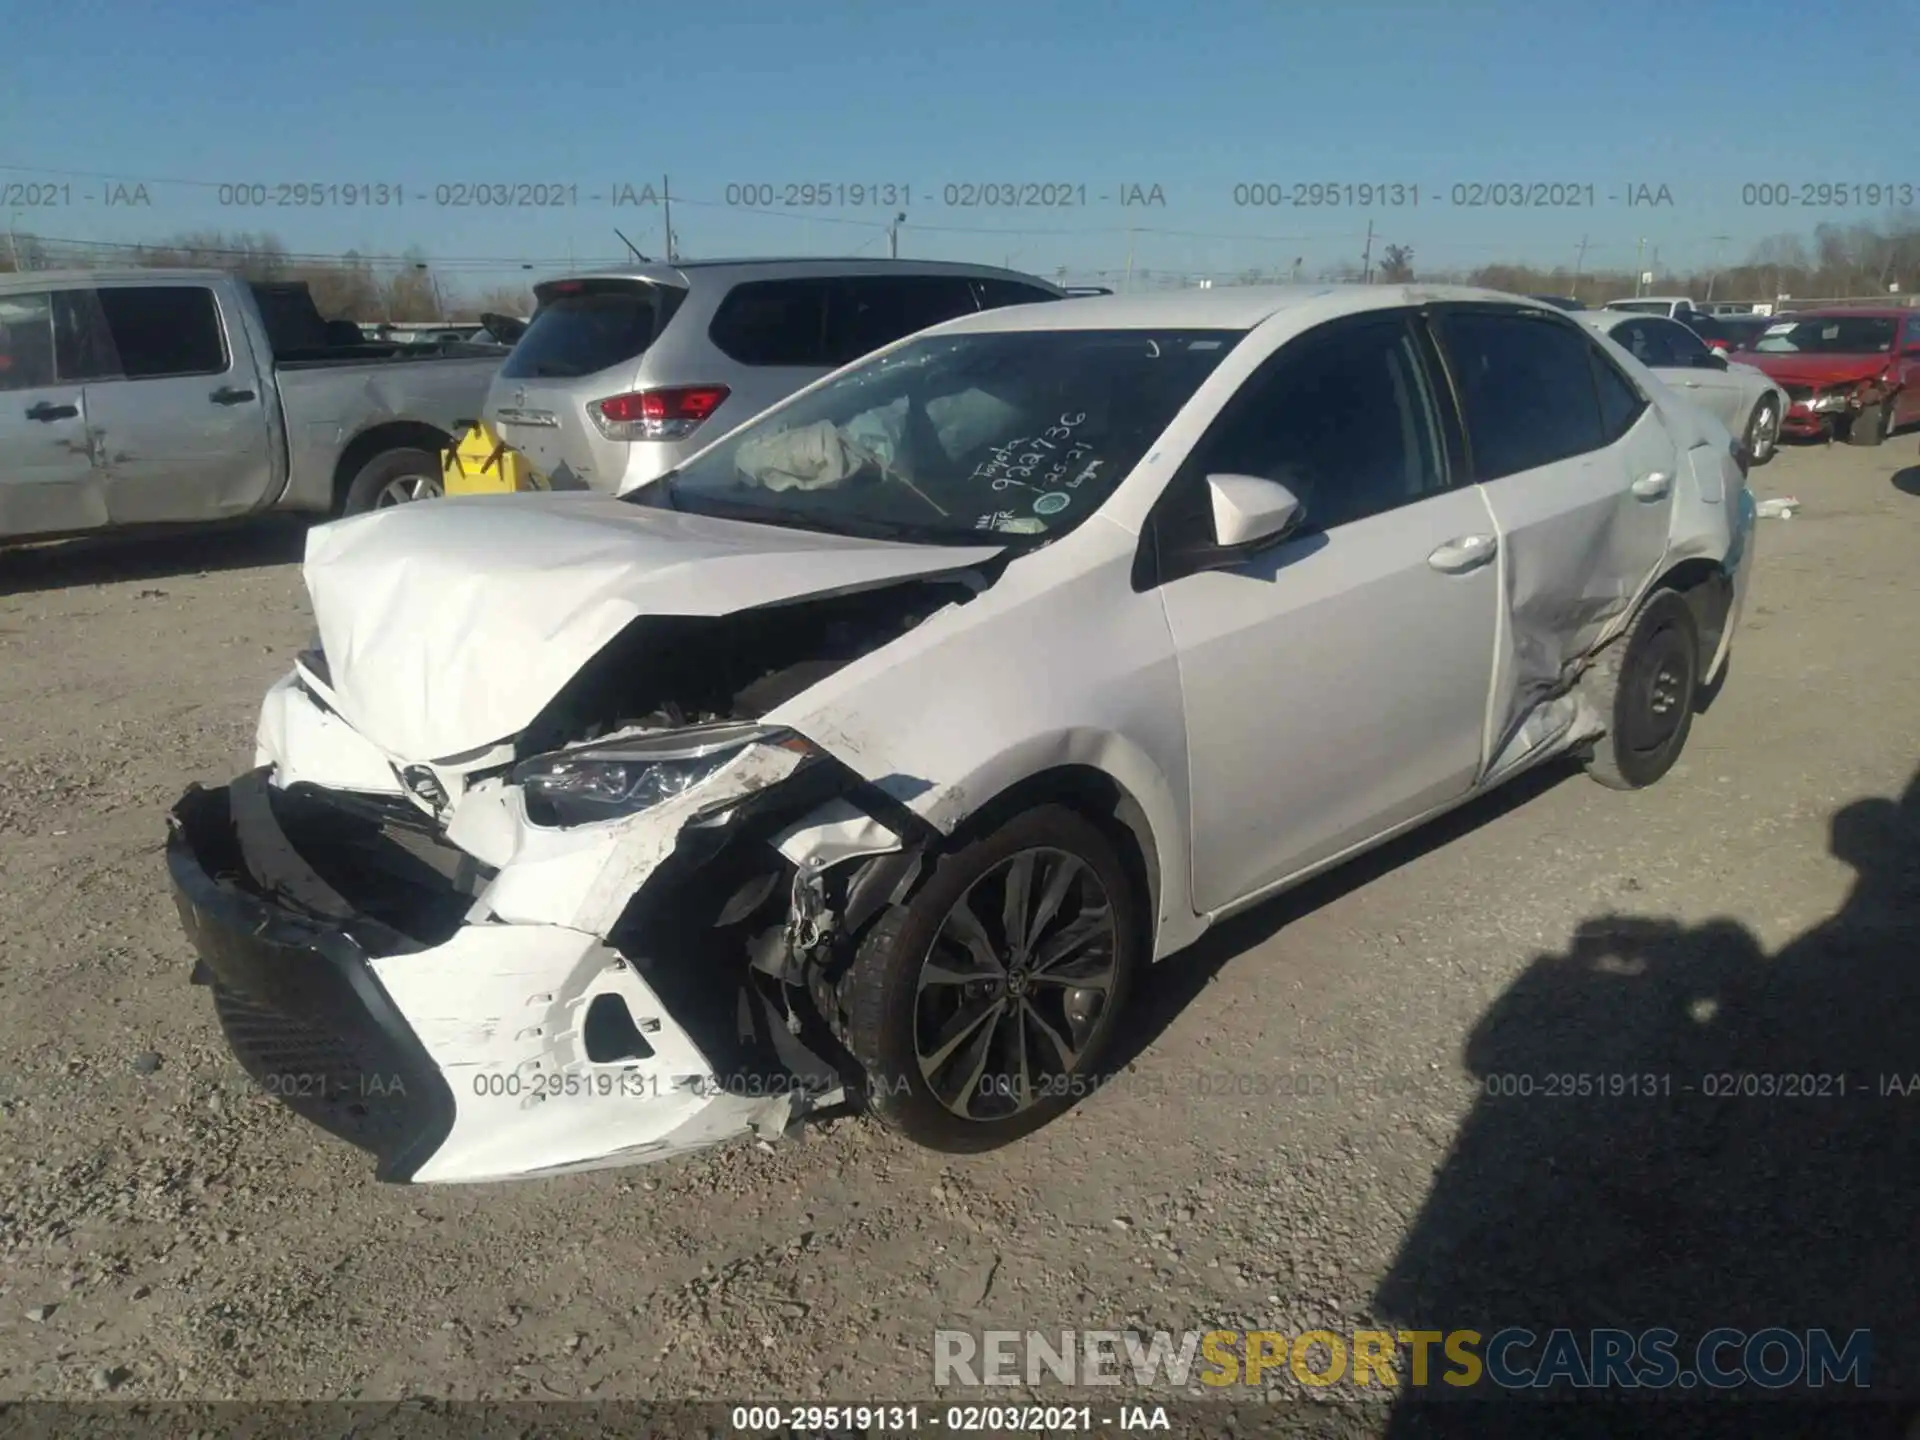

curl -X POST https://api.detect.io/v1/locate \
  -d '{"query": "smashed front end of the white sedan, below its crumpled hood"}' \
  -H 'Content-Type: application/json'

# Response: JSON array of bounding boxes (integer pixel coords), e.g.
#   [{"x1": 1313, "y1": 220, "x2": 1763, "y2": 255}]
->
[{"x1": 167, "y1": 572, "x2": 983, "y2": 1183}]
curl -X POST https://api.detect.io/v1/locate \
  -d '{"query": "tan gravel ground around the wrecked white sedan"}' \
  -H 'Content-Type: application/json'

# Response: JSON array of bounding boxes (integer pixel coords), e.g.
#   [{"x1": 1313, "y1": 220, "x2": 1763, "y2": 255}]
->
[{"x1": 0, "y1": 445, "x2": 1920, "y2": 1434}]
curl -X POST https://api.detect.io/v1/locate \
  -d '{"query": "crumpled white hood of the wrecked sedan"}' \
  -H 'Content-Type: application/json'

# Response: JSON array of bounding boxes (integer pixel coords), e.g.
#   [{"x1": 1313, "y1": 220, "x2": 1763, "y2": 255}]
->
[{"x1": 305, "y1": 492, "x2": 1000, "y2": 760}]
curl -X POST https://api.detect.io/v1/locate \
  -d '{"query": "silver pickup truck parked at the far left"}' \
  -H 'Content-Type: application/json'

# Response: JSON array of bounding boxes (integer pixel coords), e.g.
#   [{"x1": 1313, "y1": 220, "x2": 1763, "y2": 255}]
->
[{"x1": 0, "y1": 271, "x2": 507, "y2": 540}]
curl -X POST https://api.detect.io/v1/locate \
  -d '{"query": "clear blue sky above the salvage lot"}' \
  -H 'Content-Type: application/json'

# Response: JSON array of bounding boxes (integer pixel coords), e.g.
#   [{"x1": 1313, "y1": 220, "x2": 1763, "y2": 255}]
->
[{"x1": 0, "y1": 0, "x2": 1920, "y2": 295}]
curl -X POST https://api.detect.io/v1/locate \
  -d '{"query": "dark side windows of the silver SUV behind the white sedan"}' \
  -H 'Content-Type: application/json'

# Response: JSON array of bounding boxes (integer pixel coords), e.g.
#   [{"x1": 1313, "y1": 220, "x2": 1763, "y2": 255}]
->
[{"x1": 707, "y1": 275, "x2": 998, "y2": 369}]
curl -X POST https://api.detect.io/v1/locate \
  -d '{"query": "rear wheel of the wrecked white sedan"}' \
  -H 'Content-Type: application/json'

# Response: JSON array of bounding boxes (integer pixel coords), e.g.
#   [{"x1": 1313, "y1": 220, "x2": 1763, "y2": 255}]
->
[{"x1": 1582, "y1": 589, "x2": 1699, "y2": 802}]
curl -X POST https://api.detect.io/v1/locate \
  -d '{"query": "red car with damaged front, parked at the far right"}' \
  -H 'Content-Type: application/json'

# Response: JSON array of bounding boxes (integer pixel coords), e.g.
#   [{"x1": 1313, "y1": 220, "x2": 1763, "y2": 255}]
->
[{"x1": 1740, "y1": 307, "x2": 1920, "y2": 445}]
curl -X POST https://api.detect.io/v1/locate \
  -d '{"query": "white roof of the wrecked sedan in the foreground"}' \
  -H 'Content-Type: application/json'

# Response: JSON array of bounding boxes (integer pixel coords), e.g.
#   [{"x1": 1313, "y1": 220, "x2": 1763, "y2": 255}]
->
[{"x1": 921, "y1": 284, "x2": 1567, "y2": 334}]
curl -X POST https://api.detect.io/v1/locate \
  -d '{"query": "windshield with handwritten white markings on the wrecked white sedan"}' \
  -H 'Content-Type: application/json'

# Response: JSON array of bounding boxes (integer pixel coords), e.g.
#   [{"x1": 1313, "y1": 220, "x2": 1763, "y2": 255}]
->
[{"x1": 636, "y1": 330, "x2": 1242, "y2": 543}]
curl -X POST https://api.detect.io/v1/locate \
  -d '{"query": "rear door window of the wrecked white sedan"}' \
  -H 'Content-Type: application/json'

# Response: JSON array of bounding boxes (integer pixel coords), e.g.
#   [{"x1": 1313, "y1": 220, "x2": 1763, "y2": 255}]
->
[{"x1": 1438, "y1": 311, "x2": 1607, "y2": 480}]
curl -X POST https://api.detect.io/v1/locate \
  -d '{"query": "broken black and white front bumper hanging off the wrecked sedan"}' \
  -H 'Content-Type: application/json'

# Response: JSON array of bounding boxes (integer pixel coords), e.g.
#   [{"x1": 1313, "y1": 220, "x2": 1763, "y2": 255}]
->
[{"x1": 167, "y1": 768, "x2": 817, "y2": 1183}]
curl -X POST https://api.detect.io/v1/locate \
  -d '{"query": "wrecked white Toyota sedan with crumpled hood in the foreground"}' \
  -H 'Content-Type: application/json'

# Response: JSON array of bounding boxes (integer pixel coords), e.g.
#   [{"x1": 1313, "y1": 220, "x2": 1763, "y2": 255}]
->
[{"x1": 169, "y1": 286, "x2": 1753, "y2": 1181}]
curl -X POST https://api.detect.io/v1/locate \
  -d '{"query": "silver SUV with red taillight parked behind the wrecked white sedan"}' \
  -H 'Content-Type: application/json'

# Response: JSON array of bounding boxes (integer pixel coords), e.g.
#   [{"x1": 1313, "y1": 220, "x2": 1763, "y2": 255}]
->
[{"x1": 486, "y1": 259, "x2": 1064, "y2": 493}]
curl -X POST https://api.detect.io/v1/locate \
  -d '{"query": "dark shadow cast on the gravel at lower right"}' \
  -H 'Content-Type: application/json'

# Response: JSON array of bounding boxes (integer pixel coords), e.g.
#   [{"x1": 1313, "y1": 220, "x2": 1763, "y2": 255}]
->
[{"x1": 1375, "y1": 774, "x2": 1920, "y2": 1436}]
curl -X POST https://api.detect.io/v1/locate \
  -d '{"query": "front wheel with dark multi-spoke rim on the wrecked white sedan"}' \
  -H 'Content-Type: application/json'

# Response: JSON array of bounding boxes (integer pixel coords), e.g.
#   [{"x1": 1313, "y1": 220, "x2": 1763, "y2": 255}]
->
[{"x1": 841, "y1": 804, "x2": 1146, "y2": 1154}]
